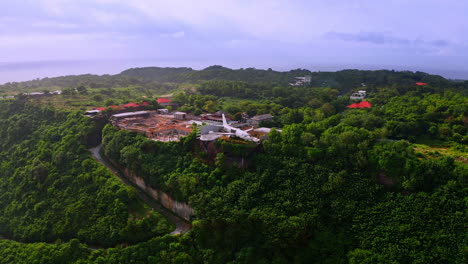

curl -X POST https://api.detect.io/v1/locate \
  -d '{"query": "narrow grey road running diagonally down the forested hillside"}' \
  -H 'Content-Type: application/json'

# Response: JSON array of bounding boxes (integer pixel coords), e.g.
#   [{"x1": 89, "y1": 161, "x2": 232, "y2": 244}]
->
[{"x1": 89, "y1": 145, "x2": 191, "y2": 235}]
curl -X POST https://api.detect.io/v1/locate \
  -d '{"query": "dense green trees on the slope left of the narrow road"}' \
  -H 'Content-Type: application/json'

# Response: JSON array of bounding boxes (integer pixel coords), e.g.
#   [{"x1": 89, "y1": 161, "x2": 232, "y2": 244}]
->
[{"x1": 0, "y1": 101, "x2": 171, "y2": 246}]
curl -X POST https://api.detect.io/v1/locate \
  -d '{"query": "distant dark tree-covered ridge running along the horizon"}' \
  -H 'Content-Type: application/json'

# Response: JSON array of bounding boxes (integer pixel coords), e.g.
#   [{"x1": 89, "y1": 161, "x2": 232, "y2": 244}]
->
[{"x1": 0, "y1": 65, "x2": 468, "y2": 97}]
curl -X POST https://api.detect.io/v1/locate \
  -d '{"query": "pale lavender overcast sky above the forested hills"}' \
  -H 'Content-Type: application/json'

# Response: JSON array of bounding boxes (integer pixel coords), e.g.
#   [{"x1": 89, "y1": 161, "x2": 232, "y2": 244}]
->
[{"x1": 0, "y1": 0, "x2": 468, "y2": 82}]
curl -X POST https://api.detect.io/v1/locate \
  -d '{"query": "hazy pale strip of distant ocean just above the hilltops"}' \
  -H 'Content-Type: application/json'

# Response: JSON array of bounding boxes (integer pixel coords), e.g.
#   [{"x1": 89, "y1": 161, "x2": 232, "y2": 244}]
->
[{"x1": 0, "y1": 59, "x2": 468, "y2": 84}]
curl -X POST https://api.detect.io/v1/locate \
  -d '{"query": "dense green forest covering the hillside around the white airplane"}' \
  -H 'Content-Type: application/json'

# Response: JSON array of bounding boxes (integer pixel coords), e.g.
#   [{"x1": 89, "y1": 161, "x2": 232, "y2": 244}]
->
[{"x1": 0, "y1": 69, "x2": 468, "y2": 263}]
